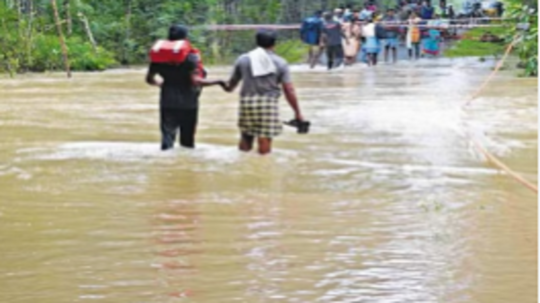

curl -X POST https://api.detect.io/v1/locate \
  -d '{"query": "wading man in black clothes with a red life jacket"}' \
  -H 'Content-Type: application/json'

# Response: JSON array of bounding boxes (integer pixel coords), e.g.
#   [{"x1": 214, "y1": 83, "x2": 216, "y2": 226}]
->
[{"x1": 146, "y1": 25, "x2": 225, "y2": 150}]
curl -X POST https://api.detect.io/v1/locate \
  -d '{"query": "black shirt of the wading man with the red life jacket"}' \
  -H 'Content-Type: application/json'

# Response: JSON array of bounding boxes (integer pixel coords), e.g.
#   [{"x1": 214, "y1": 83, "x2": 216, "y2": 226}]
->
[{"x1": 150, "y1": 55, "x2": 201, "y2": 109}]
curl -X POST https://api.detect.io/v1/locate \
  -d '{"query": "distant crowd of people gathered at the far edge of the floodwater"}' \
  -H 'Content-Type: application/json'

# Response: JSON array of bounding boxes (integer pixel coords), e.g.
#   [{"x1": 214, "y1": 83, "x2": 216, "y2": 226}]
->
[{"x1": 300, "y1": 0, "x2": 453, "y2": 70}]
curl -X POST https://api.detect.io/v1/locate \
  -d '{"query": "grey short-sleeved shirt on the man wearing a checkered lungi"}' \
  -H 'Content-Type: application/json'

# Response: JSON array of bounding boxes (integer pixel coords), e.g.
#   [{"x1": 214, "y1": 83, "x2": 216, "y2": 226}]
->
[{"x1": 230, "y1": 51, "x2": 291, "y2": 97}]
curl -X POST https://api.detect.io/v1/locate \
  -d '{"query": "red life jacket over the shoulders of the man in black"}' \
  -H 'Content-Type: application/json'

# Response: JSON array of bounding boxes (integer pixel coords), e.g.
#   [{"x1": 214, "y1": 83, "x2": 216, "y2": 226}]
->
[{"x1": 150, "y1": 40, "x2": 205, "y2": 77}]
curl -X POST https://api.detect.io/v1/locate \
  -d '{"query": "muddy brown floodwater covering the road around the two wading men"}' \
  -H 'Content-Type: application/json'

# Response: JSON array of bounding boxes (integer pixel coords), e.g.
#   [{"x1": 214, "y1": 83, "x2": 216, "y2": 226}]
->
[{"x1": 0, "y1": 59, "x2": 538, "y2": 303}]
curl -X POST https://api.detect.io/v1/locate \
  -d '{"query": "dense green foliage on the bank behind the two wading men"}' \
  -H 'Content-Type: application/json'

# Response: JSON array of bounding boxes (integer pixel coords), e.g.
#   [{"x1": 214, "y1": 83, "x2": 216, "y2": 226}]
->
[{"x1": 0, "y1": 0, "x2": 374, "y2": 73}]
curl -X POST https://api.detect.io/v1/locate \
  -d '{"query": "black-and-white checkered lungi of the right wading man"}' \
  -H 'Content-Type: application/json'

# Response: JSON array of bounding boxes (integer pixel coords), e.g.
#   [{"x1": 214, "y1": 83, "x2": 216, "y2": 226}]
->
[{"x1": 238, "y1": 95, "x2": 283, "y2": 138}]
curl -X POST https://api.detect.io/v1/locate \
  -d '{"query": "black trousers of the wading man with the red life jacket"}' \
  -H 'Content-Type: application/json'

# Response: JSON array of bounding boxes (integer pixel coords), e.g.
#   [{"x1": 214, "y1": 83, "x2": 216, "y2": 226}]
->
[{"x1": 160, "y1": 108, "x2": 198, "y2": 150}]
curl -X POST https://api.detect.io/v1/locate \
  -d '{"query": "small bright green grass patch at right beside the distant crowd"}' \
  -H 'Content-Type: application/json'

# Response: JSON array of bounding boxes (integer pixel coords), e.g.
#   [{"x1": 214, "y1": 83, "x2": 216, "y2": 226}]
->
[{"x1": 444, "y1": 27, "x2": 506, "y2": 58}]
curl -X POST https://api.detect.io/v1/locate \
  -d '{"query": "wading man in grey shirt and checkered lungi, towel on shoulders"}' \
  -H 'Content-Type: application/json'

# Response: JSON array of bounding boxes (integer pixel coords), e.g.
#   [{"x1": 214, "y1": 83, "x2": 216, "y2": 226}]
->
[{"x1": 226, "y1": 30, "x2": 304, "y2": 155}]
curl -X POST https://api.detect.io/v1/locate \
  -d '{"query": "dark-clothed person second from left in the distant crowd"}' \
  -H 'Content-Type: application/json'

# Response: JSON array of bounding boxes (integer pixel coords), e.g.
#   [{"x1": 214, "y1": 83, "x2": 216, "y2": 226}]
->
[{"x1": 322, "y1": 13, "x2": 349, "y2": 70}]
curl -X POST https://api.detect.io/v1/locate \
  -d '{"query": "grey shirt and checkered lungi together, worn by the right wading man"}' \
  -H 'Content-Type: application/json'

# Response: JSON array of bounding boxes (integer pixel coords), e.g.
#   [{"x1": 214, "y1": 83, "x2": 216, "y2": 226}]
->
[{"x1": 230, "y1": 50, "x2": 291, "y2": 138}]
